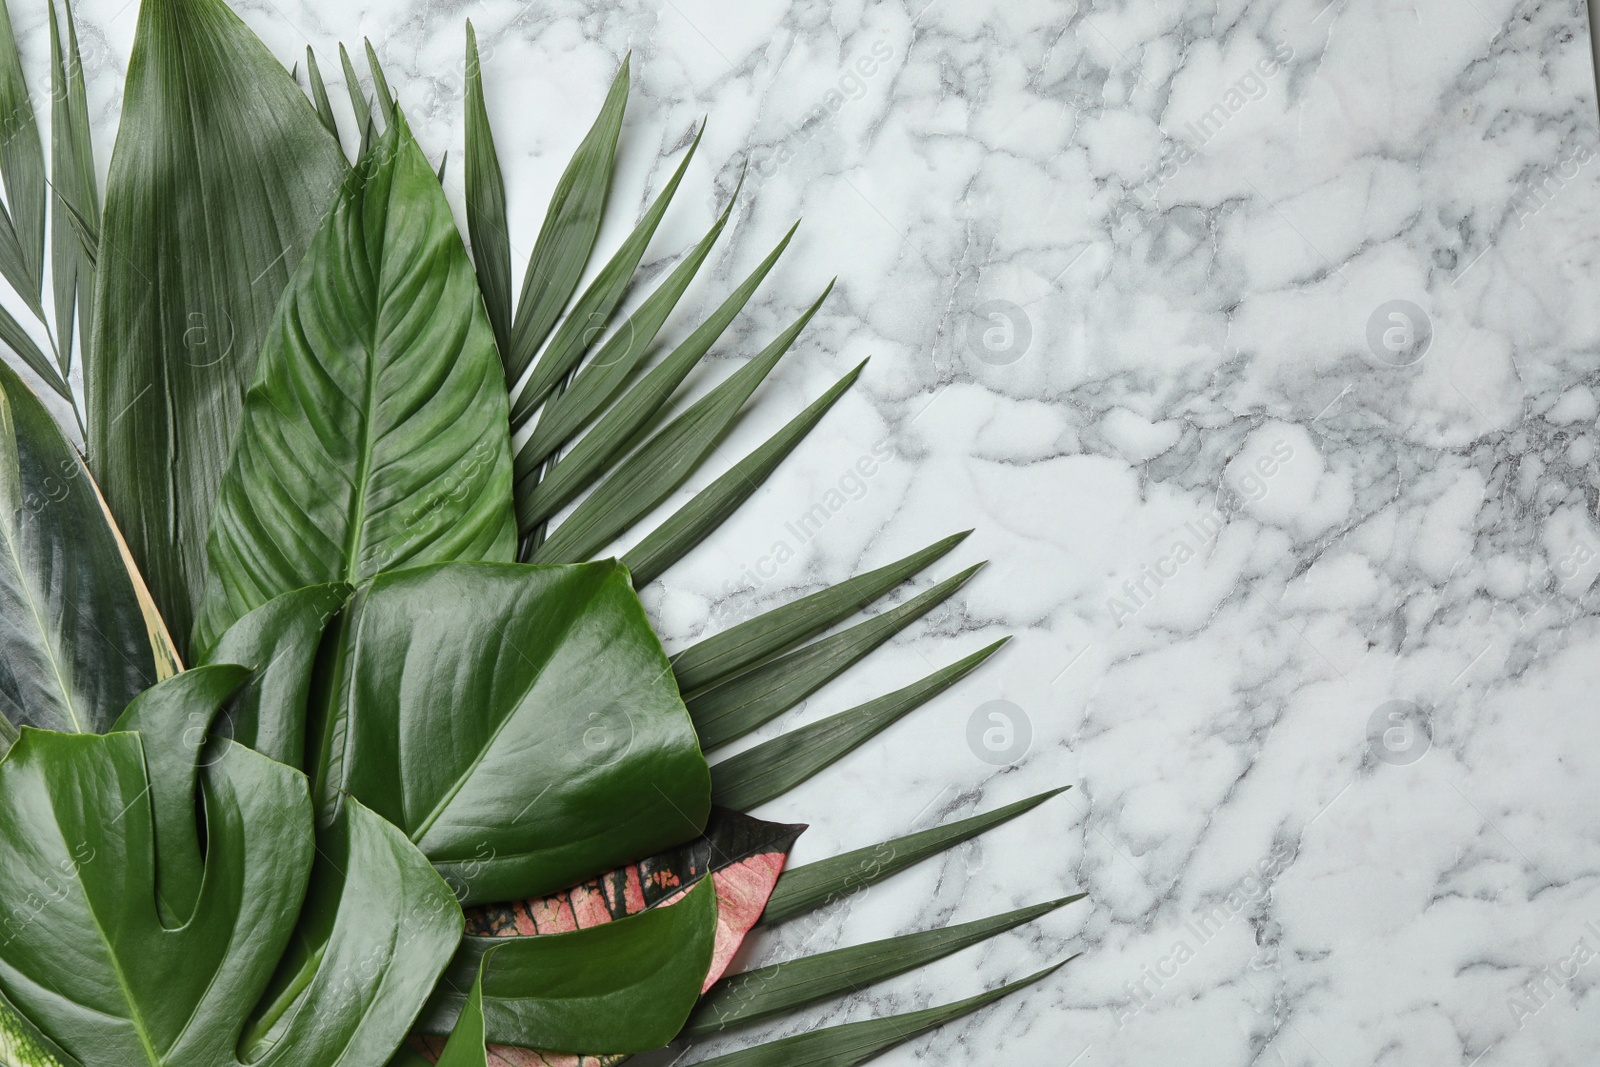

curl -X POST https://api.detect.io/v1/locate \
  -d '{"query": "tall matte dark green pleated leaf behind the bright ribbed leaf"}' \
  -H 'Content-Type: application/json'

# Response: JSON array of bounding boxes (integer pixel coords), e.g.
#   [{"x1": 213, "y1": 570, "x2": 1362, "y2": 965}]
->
[{"x1": 83, "y1": 0, "x2": 349, "y2": 653}]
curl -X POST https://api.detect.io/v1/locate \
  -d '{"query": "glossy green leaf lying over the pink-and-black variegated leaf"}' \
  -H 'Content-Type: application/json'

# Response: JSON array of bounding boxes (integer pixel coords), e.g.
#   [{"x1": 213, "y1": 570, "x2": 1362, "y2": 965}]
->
[{"x1": 421, "y1": 880, "x2": 717, "y2": 1054}]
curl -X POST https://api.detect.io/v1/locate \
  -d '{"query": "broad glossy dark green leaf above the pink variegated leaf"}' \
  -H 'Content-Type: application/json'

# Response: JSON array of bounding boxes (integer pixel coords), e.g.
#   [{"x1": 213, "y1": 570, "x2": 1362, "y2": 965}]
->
[{"x1": 315, "y1": 561, "x2": 710, "y2": 904}]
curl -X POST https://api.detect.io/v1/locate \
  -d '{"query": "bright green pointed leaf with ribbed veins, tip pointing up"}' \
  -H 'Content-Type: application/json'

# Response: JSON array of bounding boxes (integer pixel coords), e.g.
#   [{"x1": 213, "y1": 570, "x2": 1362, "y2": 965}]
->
[{"x1": 195, "y1": 112, "x2": 517, "y2": 648}]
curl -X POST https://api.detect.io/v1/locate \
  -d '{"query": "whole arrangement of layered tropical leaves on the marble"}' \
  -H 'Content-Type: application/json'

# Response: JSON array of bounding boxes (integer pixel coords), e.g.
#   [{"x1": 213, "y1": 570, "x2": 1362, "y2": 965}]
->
[{"x1": 0, "y1": 0, "x2": 1077, "y2": 1067}]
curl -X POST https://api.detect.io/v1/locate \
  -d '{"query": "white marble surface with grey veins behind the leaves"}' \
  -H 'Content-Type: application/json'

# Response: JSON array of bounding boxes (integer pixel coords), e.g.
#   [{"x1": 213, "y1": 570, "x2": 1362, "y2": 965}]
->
[{"x1": 13, "y1": 0, "x2": 1600, "y2": 1067}]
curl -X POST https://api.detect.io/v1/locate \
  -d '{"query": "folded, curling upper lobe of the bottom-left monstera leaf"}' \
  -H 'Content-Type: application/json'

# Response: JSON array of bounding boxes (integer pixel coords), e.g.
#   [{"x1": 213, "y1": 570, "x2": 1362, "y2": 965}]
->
[{"x1": 112, "y1": 664, "x2": 250, "y2": 929}]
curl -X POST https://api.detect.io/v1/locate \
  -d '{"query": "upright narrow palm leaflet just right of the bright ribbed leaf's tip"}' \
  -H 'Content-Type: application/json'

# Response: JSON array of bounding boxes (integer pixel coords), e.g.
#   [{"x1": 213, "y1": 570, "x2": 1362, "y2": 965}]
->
[{"x1": 466, "y1": 19, "x2": 510, "y2": 358}]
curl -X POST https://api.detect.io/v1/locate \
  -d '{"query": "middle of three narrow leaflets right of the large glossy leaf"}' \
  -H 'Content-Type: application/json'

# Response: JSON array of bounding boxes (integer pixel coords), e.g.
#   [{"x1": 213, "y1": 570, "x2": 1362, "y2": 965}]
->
[{"x1": 686, "y1": 563, "x2": 982, "y2": 750}]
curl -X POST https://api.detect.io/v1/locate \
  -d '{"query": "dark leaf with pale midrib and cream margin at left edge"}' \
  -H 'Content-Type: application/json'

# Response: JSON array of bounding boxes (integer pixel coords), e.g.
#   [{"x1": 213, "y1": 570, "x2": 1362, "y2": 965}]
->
[{"x1": 0, "y1": 365, "x2": 157, "y2": 739}]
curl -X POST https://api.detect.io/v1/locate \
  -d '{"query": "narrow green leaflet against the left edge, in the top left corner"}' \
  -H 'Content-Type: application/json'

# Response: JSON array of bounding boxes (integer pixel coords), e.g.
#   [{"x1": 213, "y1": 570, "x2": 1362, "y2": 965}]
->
[{"x1": 0, "y1": 2, "x2": 45, "y2": 308}]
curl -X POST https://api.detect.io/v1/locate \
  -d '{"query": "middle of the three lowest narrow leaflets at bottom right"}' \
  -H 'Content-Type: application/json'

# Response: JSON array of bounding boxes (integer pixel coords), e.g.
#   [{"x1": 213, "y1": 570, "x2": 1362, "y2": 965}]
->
[{"x1": 683, "y1": 893, "x2": 1086, "y2": 1038}]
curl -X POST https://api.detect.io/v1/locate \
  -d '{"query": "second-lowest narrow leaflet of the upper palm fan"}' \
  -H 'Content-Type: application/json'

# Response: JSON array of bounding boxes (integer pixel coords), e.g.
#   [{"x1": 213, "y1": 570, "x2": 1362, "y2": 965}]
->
[{"x1": 534, "y1": 283, "x2": 834, "y2": 563}]
